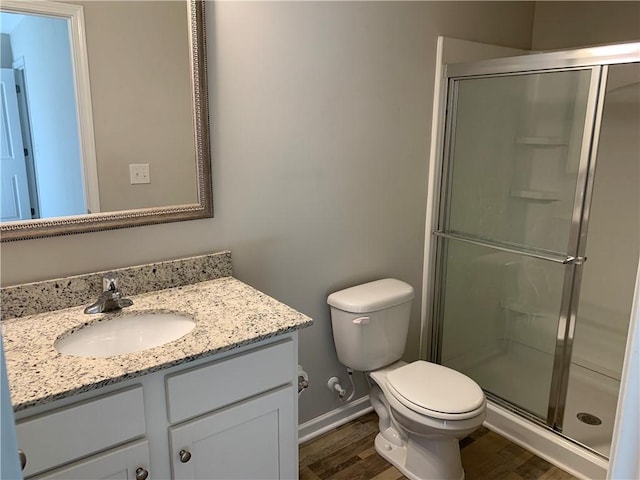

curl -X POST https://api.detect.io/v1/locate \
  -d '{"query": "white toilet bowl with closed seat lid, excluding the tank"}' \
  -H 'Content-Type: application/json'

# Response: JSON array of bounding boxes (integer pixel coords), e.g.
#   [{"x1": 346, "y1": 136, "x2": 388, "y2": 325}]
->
[{"x1": 369, "y1": 361, "x2": 486, "y2": 480}]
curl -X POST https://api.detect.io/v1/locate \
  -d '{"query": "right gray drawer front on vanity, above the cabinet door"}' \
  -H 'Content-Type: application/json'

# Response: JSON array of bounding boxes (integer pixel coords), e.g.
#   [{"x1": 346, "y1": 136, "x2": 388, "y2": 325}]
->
[{"x1": 166, "y1": 339, "x2": 295, "y2": 423}]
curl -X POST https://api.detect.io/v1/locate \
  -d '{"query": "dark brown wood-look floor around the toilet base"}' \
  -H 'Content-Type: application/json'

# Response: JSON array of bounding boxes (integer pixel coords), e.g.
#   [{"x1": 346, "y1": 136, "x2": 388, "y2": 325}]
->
[{"x1": 300, "y1": 413, "x2": 575, "y2": 480}]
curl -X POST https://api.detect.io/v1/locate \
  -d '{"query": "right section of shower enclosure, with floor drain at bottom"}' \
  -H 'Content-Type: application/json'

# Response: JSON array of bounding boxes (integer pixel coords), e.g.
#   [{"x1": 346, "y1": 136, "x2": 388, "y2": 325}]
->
[{"x1": 562, "y1": 63, "x2": 640, "y2": 457}]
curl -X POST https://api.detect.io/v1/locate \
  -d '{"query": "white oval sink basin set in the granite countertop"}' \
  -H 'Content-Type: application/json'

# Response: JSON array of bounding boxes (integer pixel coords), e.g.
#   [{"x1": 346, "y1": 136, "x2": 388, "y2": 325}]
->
[{"x1": 54, "y1": 313, "x2": 196, "y2": 358}]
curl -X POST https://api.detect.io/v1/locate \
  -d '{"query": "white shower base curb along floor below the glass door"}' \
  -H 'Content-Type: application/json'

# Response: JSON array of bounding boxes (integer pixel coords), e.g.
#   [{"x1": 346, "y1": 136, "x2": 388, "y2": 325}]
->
[{"x1": 484, "y1": 402, "x2": 609, "y2": 480}]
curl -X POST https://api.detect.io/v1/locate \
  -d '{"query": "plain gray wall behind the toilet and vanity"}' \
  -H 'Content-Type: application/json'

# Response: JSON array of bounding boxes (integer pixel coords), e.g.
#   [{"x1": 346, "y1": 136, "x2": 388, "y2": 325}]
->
[{"x1": 0, "y1": 2, "x2": 534, "y2": 422}]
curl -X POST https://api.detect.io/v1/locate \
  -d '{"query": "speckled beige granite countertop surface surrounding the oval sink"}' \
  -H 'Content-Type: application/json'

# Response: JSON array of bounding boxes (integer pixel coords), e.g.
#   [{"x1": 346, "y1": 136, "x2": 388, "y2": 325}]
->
[{"x1": 2, "y1": 277, "x2": 312, "y2": 411}]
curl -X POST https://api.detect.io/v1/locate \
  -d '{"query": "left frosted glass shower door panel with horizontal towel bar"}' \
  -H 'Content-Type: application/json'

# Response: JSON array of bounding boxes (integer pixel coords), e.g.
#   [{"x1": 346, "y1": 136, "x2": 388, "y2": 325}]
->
[{"x1": 435, "y1": 67, "x2": 601, "y2": 425}]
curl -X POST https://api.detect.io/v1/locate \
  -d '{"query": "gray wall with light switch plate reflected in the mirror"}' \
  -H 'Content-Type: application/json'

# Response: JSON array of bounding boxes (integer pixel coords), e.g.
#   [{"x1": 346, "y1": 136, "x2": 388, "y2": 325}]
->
[{"x1": 76, "y1": 0, "x2": 197, "y2": 212}]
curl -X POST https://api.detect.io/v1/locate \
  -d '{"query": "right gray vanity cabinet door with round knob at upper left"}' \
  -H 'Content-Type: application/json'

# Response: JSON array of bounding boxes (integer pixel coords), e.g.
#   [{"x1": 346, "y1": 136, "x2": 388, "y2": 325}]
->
[{"x1": 169, "y1": 387, "x2": 298, "y2": 480}]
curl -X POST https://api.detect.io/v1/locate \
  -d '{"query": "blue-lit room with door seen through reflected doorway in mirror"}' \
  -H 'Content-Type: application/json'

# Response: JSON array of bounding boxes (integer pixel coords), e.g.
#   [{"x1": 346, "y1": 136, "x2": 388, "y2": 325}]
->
[{"x1": 0, "y1": 12, "x2": 87, "y2": 222}]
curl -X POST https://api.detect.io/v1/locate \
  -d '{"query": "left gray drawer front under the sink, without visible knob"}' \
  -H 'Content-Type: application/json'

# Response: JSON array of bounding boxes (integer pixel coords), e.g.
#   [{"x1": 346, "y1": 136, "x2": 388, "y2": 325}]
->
[{"x1": 16, "y1": 386, "x2": 145, "y2": 476}]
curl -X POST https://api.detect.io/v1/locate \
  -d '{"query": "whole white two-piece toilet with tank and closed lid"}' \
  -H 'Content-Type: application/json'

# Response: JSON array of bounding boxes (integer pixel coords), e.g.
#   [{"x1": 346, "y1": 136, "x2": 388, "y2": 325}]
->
[{"x1": 327, "y1": 278, "x2": 486, "y2": 480}]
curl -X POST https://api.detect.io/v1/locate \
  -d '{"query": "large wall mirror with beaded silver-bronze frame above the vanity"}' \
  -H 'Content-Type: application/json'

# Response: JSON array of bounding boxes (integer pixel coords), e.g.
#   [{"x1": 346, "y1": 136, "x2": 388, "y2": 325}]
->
[{"x1": 0, "y1": 0, "x2": 213, "y2": 241}]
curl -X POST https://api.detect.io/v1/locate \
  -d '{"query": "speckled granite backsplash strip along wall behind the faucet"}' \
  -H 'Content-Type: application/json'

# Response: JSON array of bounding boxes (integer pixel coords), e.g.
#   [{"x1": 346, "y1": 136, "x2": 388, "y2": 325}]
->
[{"x1": 0, "y1": 251, "x2": 232, "y2": 320}]
